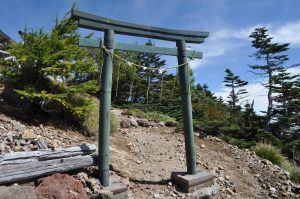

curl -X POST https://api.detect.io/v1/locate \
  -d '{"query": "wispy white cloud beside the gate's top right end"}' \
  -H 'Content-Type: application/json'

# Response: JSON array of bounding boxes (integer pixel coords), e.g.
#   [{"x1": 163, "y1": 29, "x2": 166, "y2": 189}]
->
[{"x1": 193, "y1": 20, "x2": 300, "y2": 69}]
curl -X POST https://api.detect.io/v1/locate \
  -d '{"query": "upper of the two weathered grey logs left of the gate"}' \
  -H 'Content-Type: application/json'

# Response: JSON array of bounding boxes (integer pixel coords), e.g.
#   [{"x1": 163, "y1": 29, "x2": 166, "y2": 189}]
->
[{"x1": 0, "y1": 144, "x2": 97, "y2": 166}]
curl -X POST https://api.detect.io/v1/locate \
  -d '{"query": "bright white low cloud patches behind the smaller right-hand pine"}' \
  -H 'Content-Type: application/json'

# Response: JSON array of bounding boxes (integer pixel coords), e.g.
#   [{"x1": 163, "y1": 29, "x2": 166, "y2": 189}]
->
[{"x1": 215, "y1": 83, "x2": 268, "y2": 114}]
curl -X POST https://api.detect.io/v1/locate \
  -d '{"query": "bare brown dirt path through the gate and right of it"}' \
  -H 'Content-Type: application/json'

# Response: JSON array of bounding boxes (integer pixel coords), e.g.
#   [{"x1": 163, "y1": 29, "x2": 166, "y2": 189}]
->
[{"x1": 111, "y1": 123, "x2": 296, "y2": 199}]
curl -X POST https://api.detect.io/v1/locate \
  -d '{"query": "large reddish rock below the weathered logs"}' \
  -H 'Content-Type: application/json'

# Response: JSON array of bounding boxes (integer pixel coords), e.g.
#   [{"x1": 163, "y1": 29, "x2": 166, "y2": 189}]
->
[{"x1": 35, "y1": 174, "x2": 88, "y2": 199}]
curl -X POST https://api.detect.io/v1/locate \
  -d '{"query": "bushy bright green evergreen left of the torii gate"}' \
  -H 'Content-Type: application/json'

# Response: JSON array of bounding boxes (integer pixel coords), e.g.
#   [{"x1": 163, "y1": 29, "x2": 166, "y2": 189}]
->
[{"x1": 2, "y1": 18, "x2": 99, "y2": 118}]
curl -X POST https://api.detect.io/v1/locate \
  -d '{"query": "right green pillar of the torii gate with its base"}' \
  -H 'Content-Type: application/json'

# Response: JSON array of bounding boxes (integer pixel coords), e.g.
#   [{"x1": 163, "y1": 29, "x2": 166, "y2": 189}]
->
[{"x1": 171, "y1": 40, "x2": 215, "y2": 192}]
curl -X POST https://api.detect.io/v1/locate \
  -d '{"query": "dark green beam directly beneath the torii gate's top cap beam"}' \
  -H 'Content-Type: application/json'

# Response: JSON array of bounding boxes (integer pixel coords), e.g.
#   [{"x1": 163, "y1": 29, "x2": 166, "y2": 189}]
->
[{"x1": 78, "y1": 19, "x2": 204, "y2": 43}]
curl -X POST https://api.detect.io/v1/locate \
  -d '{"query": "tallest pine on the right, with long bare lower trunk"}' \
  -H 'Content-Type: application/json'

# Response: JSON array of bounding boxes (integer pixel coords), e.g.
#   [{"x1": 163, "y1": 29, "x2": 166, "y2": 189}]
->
[{"x1": 249, "y1": 27, "x2": 289, "y2": 131}]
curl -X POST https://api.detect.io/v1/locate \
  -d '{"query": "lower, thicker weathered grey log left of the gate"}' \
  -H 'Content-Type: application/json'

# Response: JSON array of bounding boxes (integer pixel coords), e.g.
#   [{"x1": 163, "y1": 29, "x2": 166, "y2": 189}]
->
[{"x1": 0, "y1": 155, "x2": 96, "y2": 184}]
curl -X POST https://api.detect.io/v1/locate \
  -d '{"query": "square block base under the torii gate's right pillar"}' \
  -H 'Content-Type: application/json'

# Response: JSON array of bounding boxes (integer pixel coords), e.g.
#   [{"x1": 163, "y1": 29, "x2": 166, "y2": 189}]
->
[{"x1": 171, "y1": 171, "x2": 215, "y2": 193}]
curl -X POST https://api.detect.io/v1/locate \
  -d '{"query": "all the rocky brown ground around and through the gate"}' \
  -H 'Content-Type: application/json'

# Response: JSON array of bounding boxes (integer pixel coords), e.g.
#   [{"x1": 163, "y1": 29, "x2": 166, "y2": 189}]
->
[{"x1": 0, "y1": 107, "x2": 300, "y2": 199}]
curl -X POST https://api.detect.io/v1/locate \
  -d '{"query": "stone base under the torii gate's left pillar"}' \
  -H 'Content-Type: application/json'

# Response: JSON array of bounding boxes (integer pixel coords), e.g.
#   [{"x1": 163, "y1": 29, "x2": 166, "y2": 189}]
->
[{"x1": 99, "y1": 183, "x2": 128, "y2": 199}]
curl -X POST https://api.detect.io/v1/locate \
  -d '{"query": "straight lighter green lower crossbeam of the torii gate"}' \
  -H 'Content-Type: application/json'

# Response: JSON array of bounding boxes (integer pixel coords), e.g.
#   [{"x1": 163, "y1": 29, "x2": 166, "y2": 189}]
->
[{"x1": 79, "y1": 38, "x2": 202, "y2": 59}]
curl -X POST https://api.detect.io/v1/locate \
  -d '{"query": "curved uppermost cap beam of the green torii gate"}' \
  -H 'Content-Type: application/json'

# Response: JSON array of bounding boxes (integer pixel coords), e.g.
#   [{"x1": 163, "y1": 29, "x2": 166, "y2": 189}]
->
[{"x1": 71, "y1": 9, "x2": 209, "y2": 38}]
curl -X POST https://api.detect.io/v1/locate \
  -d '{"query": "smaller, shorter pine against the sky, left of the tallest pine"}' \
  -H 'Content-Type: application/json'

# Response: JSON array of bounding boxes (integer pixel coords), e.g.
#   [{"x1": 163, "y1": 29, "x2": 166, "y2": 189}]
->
[{"x1": 223, "y1": 68, "x2": 248, "y2": 124}]
